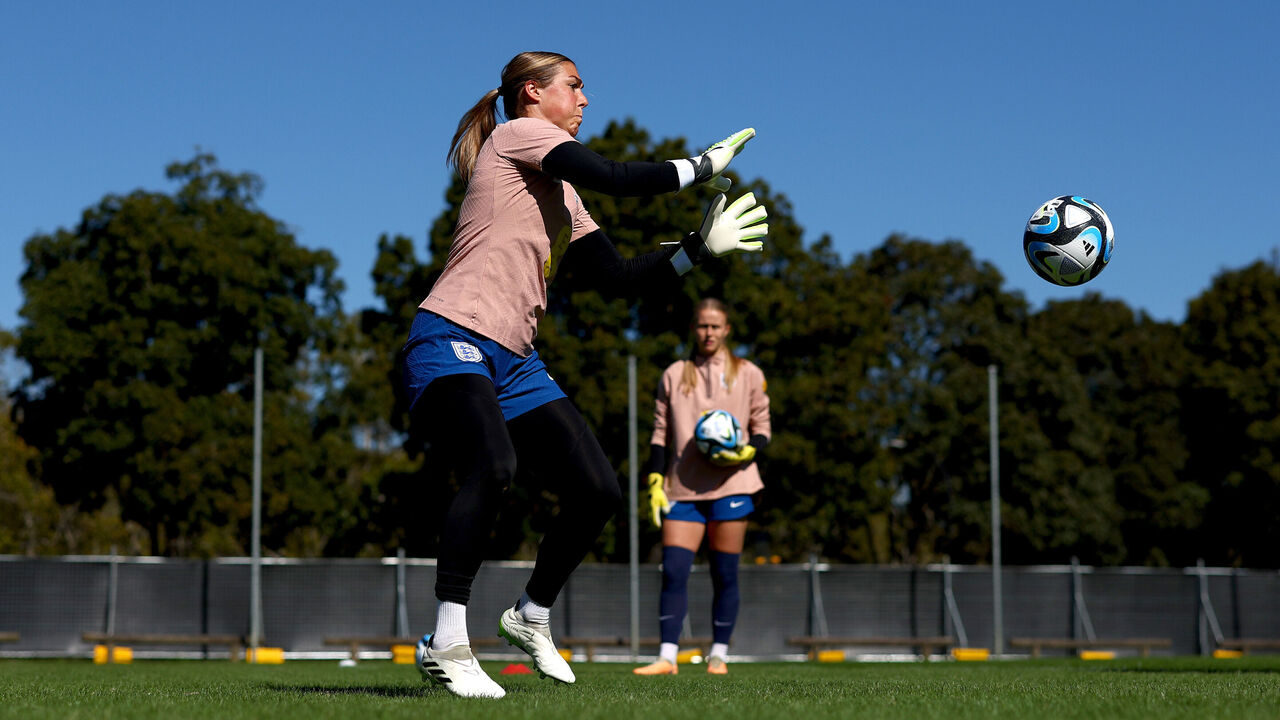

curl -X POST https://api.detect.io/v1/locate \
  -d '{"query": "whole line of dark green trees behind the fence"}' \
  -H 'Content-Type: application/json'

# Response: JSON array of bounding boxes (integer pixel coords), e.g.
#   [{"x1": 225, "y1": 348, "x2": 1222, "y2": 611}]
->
[{"x1": 0, "y1": 122, "x2": 1280, "y2": 568}]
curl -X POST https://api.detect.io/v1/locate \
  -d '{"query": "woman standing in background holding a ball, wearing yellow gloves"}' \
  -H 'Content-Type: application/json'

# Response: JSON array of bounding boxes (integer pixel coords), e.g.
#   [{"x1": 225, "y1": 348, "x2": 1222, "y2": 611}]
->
[{"x1": 635, "y1": 299, "x2": 771, "y2": 675}]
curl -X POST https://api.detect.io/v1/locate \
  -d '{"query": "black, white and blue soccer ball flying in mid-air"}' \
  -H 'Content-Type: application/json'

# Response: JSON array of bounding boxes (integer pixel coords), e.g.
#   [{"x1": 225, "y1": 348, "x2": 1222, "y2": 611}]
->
[{"x1": 1023, "y1": 195, "x2": 1115, "y2": 286}]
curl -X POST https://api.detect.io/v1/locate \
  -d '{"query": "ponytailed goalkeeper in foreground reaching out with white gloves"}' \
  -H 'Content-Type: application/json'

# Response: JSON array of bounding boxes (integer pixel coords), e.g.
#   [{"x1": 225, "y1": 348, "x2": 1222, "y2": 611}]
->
[{"x1": 402, "y1": 53, "x2": 768, "y2": 698}]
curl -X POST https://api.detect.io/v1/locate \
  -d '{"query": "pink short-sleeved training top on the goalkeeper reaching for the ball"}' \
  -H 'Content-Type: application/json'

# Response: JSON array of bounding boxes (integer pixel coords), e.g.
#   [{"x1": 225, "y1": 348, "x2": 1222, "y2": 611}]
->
[{"x1": 419, "y1": 118, "x2": 599, "y2": 357}]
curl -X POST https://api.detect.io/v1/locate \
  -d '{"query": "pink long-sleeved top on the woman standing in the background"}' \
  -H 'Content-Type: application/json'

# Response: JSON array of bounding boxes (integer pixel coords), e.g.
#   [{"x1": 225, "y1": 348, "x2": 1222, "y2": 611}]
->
[{"x1": 650, "y1": 352, "x2": 772, "y2": 502}]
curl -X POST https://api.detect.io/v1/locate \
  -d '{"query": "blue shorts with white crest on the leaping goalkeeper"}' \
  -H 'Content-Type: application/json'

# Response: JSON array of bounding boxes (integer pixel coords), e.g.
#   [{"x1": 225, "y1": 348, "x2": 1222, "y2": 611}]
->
[{"x1": 402, "y1": 310, "x2": 564, "y2": 420}]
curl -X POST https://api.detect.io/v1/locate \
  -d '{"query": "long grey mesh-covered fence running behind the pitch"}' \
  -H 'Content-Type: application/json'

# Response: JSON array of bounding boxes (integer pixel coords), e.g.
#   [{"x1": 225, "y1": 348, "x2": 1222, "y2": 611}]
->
[{"x1": 0, "y1": 556, "x2": 1280, "y2": 657}]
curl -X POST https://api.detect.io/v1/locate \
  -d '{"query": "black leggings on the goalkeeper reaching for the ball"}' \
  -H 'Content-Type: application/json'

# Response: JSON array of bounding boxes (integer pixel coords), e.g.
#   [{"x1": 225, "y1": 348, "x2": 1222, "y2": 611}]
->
[{"x1": 413, "y1": 374, "x2": 622, "y2": 607}]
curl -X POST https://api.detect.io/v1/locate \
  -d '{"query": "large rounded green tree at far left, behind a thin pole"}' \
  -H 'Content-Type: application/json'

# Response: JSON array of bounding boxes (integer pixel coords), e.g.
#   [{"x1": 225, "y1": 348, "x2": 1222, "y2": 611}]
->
[{"x1": 17, "y1": 154, "x2": 358, "y2": 555}]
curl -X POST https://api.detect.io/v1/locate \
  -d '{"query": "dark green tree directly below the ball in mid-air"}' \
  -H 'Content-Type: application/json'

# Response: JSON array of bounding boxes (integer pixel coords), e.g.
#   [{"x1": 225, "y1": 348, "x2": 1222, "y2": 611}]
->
[{"x1": 1024, "y1": 293, "x2": 1208, "y2": 565}]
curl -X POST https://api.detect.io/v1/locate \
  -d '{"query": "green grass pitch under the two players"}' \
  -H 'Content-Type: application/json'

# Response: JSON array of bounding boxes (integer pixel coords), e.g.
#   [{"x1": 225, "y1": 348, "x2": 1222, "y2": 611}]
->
[{"x1": 0, "y1": 656, "x2": 1280, "y2": 720}]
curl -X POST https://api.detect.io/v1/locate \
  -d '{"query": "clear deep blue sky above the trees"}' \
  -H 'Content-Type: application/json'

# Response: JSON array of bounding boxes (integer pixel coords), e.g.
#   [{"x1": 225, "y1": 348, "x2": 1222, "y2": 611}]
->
[{"x1": 0, "y1": 0, "x2": 1280, "y2": 368}]
